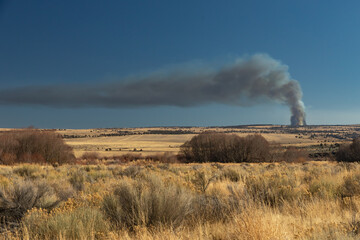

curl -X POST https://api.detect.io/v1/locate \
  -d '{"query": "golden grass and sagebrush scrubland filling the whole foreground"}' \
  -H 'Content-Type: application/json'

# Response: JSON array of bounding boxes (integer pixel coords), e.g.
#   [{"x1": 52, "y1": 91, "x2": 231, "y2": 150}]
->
[{"x1": 0, "y1": 160, "x2": 360, "y2": 239}]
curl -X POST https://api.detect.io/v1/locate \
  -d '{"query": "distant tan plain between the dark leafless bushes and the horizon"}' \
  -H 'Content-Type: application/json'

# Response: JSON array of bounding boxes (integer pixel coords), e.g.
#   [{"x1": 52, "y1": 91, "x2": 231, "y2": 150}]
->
[{"x1": 57, "y1": 125, "x2": 360, "y2": 157}]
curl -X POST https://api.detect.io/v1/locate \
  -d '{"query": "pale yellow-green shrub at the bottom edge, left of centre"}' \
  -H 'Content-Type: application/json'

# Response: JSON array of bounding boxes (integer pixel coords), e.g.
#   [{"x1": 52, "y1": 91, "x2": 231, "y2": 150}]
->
[{"x1": 23, "y1": 207, "x2": 109, "y2": 239}]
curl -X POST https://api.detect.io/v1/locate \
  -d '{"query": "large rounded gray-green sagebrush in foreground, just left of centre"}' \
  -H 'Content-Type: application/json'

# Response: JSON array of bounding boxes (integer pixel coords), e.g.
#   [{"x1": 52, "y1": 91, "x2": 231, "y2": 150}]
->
[{"x1": 102, "y1": 176, "x2": 192, "y2": 230}]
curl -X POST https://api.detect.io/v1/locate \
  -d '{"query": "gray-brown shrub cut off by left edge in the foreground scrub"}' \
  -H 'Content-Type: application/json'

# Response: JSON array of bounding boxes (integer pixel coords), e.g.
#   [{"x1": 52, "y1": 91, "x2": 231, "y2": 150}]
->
[{"x1": 0, "y1": 181, "x2": 59, "y2": 224}]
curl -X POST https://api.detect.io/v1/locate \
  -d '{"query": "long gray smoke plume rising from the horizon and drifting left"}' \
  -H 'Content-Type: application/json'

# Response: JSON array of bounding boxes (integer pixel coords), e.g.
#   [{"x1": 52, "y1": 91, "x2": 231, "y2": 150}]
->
[{"x1": 0, "y1": 54, "x2": 306, "y2": 126}]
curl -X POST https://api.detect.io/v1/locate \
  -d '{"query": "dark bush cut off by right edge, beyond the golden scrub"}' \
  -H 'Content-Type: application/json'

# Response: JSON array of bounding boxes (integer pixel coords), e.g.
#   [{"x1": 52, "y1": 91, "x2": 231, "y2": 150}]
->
[{"x1": 335, "y1": 138, "x2": 360, "y2": 162}]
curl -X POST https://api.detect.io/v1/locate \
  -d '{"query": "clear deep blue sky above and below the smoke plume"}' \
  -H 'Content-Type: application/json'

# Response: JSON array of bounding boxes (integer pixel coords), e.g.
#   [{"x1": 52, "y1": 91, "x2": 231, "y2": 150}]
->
[{"x1": 0, "y1": 0, "x2": 360, "y2": 128}]
